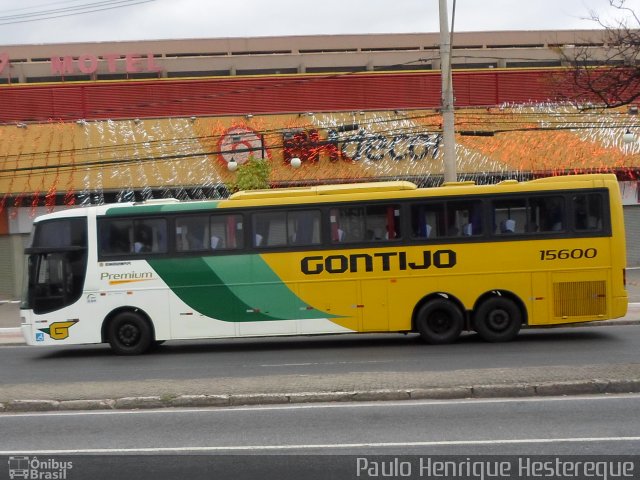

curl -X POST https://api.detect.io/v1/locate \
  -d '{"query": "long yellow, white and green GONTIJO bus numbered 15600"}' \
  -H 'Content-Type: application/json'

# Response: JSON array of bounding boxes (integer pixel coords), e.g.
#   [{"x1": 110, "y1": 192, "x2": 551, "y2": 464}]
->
[{"x1": 21, "y1": 174, "x2": 627, "y2": 354}]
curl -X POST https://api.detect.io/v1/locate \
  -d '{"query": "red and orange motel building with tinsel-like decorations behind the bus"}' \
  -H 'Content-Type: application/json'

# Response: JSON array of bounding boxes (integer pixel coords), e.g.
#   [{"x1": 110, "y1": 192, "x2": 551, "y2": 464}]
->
[{"x1": 0, "y1": 31, "x2": 640, "y2": 298}]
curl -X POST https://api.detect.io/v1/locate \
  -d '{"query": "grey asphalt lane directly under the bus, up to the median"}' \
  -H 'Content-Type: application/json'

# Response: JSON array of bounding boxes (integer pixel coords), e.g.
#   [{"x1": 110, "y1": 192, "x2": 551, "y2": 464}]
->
[{"x1": 0, "y1": 325, "x2": 640, "y2": 385}]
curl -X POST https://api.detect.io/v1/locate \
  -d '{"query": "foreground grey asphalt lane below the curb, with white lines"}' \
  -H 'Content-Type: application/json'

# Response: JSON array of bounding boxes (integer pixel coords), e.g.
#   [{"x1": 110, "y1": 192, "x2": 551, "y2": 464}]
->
[{"x1": 0, "y1": 394, "x2": 640, "y2": 478}]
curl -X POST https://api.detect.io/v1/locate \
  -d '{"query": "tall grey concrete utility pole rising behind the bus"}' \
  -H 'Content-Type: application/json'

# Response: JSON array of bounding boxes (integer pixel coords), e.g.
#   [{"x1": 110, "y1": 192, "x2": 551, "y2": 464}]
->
[{"x1": 439, "y1": 0, "x2": 458, "y2": 182}]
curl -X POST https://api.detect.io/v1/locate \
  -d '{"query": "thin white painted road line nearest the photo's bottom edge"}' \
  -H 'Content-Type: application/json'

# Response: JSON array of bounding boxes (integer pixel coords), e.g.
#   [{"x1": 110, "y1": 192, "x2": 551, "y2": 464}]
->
[{"x1": 0, "y1": 437, "x2": 640, "y2": 455}]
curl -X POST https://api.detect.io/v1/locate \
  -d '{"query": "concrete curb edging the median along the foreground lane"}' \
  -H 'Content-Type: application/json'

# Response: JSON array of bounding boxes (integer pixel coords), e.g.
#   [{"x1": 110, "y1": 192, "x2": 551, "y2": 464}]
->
[{"x1": 0, "y1": 379, "x2": 640, "y2": 413}]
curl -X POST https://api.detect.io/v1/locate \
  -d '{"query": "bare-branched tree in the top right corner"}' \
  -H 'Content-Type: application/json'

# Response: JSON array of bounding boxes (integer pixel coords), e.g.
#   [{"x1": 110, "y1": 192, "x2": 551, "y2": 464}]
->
[{"x1": 561, "y1": 0, "x2": 640, "y2": 108}]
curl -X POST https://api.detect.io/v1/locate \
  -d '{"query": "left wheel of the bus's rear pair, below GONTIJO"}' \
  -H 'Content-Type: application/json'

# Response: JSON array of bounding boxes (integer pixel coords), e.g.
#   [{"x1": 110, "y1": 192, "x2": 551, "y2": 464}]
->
[{"x1": 415, "y1": 298, "x2": 464, "y2": 345}]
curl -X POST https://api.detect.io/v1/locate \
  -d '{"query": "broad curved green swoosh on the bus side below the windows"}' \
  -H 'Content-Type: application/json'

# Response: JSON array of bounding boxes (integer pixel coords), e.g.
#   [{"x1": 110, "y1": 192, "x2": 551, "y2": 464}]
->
[{"x1": 148, "y1": 255, "x2": 335, "y2": 322}]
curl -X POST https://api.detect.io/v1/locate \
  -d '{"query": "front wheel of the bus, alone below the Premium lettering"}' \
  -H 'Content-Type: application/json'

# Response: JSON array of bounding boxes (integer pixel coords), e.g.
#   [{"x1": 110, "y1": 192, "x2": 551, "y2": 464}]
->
[{"x1": 108, "y1": 311, "x2": 153, "y2": 355}]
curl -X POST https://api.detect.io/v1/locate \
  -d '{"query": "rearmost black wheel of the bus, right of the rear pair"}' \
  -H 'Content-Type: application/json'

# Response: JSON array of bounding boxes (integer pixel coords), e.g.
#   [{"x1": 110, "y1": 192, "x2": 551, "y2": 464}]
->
[{"x1": 473, "y1": 297, "x2": 522, "y2": 342}]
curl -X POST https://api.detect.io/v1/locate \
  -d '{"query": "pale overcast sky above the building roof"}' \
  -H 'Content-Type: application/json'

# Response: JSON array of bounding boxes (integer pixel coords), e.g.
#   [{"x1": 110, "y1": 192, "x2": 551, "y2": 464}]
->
[{"x1": 0, "y1": 0, "x2": 640, "y2": 46}]
